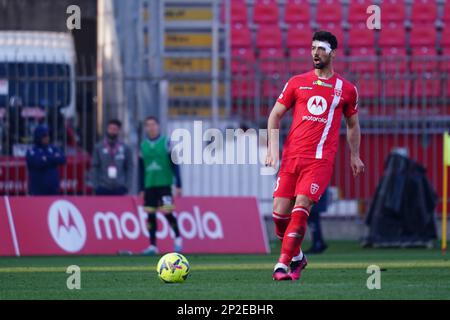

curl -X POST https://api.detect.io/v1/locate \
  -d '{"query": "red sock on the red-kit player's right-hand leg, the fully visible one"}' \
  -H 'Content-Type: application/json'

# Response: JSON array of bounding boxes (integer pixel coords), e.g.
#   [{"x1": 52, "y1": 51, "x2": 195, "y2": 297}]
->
[{"x1": 278, "y1": 206, "x2": 309, "y2": 265}]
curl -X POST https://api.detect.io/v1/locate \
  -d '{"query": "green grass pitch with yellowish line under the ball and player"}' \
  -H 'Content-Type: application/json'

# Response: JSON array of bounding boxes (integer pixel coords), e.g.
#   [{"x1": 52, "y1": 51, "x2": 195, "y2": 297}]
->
[{"x1": 0, "y1": 242, "x2": 450, "y2": 300}]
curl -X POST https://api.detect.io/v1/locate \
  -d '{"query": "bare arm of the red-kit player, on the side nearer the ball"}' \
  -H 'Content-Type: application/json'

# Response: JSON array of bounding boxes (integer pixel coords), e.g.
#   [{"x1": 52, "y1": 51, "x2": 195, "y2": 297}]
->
[{"x1": 266, "y1": 101, "x2": 288, "y2": 168}]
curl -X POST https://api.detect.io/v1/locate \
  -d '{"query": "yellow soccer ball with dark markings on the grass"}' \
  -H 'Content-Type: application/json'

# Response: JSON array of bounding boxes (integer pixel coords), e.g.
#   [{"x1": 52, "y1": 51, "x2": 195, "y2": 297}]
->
[{"x1": 156, "y1": 252, "x2": 191, "y2": 283}]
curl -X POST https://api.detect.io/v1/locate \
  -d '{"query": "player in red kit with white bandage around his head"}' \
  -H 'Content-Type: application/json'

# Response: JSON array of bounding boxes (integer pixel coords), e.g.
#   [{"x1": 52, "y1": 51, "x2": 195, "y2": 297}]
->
[{"x1": 266, "y1": 31, "x2": 364, "y2": 280}]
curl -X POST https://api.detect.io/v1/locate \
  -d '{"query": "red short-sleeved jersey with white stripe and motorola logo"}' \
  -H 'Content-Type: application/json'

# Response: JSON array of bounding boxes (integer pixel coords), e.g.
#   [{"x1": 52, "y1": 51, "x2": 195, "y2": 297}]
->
[{"x1": 277, "y1": 70, "x2": 358, "y2": 161}]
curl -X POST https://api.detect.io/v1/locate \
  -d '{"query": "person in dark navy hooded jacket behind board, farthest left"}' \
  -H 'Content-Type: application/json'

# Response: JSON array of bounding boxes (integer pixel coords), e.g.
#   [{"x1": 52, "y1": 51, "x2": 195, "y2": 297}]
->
[{"x1": 26, "y1": 125, "x2": 66, "y2": 196}]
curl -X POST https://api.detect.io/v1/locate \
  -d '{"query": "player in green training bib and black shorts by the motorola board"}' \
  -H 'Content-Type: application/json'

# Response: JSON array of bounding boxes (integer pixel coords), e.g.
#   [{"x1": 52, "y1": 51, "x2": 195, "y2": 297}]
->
[{"x1": 139, "y1": 117, "x2": 182, "y2": 255}]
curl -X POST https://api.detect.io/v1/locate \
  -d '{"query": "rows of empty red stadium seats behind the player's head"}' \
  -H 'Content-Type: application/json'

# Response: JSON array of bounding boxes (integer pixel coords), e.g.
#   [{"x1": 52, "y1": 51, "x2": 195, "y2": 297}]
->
[{"x1": 225, "y1": 0, "x2": 450, "y2": 109}]
